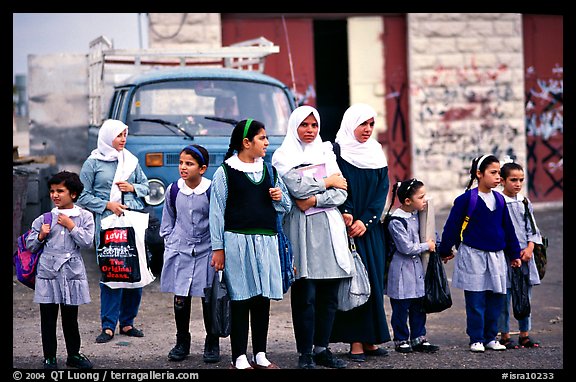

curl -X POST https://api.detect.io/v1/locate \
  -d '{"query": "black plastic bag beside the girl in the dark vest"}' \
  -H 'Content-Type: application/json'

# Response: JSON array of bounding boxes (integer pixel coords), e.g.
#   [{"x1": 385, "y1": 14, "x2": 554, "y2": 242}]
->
[{"x1": 204, "y1": 271, "x2": 232, "y2": 338}]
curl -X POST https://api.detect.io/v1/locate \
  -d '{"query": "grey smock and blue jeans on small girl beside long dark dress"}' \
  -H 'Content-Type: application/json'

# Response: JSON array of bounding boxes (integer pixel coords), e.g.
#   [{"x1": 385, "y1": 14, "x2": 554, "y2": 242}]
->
[{"x1": 386, "y1": 208, "x2": 429, "y2": 345}]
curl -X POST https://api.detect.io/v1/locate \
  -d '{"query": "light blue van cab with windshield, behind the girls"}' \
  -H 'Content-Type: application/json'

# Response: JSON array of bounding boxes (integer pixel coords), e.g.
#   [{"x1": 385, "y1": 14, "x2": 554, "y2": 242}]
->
[{"x1": 89, "y1": 67, "x2": 295, "y2": 219}]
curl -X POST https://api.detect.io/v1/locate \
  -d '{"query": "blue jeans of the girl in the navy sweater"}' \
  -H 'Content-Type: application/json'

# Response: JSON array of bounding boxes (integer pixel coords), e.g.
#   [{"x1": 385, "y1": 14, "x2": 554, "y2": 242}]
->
[{"x1": 464, "y1": 290, "x2": 505, "y2": 344}]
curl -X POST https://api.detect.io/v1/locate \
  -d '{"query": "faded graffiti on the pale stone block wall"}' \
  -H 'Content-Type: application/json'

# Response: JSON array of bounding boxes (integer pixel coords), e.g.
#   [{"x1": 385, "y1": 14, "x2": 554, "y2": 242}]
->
[{"x1": 411, "y1": 61, "x2": 523, "y2": 185}]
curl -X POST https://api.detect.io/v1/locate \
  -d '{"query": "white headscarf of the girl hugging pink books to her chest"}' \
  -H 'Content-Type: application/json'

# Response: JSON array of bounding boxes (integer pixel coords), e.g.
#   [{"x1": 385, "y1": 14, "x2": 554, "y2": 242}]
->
[{"x1": 272, "y1": 106, "x2": 340, "y2": 176}]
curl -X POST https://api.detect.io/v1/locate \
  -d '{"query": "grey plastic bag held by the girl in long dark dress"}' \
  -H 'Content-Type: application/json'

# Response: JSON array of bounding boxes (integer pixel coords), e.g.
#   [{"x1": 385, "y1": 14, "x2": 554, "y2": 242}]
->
[{"x1": 338, "y1": 237, "x2": 371, "y2": 311}]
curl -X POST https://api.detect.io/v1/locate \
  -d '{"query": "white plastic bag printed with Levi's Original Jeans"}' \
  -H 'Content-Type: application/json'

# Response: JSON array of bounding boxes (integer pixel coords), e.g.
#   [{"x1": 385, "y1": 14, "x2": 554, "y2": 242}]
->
[{"x1": 97, "y1": 211, "x2": 154, "y2": 288}]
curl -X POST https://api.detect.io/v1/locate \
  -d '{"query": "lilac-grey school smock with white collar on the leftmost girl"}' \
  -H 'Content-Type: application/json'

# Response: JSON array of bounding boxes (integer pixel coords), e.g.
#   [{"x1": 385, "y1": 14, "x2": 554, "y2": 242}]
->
[{"x1": 26, "y1": 207, "x2": 94, "y2": 305}]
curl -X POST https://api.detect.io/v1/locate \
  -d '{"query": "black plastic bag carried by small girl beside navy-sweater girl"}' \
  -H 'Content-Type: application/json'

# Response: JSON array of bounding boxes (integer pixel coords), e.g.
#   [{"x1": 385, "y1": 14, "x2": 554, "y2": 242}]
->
[{"x1": 424, "y1": 252, "x2": 452, "y2": 313}]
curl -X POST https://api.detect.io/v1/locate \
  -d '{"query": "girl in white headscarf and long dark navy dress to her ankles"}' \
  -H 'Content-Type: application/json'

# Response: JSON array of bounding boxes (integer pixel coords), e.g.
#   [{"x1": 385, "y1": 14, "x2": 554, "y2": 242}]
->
[{"x1": 330, "y1": 104, "x2": 390, "y2": 362}]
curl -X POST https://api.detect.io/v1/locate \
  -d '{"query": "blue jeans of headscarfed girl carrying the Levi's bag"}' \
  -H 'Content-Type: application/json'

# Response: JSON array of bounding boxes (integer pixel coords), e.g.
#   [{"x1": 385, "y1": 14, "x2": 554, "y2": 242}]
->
[{"x1": 100, "y1": 283, "x2": 142, "y2": 332}]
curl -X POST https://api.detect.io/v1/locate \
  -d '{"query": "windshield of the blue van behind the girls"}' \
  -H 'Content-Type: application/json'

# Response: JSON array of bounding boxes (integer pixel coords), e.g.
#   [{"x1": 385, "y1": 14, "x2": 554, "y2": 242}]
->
[{"x1": 128, "y1": 79, "x2": 290, "y2": 137}]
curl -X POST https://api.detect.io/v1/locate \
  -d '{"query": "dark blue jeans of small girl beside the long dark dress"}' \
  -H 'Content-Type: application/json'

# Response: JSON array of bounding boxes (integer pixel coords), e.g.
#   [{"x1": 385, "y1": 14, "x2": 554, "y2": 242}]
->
[{"x1": 390, "y1": 297, "x2": 426, "y2": 341}]
